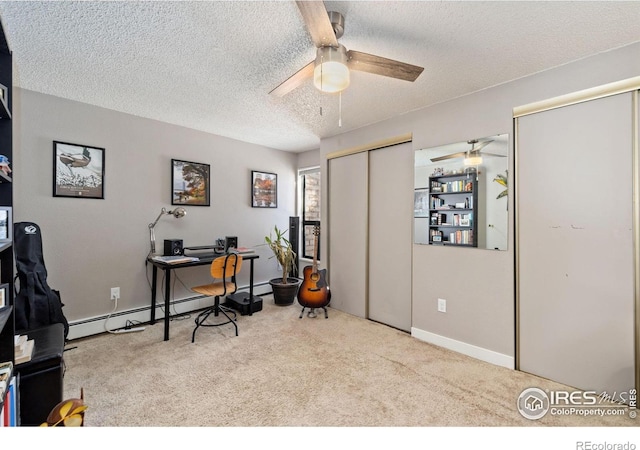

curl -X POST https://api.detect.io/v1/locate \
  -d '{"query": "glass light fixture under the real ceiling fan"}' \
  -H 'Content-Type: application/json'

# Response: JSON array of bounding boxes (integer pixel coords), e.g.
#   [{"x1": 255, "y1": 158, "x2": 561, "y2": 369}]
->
[{"x1": 313, "y1": 45, "x2": 351, "y2": 93}]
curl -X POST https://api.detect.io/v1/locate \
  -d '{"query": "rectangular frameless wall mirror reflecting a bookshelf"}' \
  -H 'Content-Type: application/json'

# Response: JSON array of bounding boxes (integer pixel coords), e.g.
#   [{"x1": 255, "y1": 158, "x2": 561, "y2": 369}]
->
[{"x1": 414, "y1": 134, "x2": 509, "y2": 250}]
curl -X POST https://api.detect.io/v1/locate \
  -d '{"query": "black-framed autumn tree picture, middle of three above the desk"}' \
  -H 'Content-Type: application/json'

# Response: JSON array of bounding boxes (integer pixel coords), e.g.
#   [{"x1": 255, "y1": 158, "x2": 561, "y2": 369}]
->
[{"x1": 171, "y1": 159, "x2": 211, "y2": 206}]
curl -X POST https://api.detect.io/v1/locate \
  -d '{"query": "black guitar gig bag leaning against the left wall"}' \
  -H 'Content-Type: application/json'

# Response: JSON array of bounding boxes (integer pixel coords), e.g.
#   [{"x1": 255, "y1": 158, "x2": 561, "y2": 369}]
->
[{"x1": 13, "y1": 222, "x2": 69, "y2": 340}]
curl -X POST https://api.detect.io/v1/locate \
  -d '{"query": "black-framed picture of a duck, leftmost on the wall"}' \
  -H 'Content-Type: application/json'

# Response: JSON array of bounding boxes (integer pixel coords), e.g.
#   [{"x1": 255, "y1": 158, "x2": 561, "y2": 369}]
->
[{"x1": 53, "y1": 141, "x2": 105, "y2": 199}]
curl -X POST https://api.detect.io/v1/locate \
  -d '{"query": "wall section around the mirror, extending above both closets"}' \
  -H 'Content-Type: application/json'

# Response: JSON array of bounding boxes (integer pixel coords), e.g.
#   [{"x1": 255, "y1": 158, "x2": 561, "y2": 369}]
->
[{"x1": 320, "y1": 43, "x2": 640, "y2": 367}]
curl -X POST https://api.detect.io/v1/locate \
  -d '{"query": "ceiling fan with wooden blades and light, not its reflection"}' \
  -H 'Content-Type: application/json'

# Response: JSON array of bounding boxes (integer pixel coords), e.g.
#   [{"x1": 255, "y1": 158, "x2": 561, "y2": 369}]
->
[{"x1": 269, "y1": 1, "x2": 424, "y2": 96}]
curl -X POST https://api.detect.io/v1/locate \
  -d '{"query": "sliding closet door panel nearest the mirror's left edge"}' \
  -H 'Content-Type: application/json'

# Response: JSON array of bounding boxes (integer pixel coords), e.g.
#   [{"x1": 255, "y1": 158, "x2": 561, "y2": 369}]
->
[{"x1": 369, "y1": 143, "x2": 413, "y2": 331}]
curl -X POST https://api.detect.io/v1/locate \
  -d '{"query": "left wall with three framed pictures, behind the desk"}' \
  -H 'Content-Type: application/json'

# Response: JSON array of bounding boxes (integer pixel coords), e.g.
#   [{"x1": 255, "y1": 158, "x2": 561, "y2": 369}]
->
[{"x1": 12, "y1": 89, "x2": 297, "y2": 336}]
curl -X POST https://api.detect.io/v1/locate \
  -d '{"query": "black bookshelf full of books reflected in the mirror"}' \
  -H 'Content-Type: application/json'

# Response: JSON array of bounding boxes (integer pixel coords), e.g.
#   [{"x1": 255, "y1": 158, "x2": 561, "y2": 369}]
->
[{"x1": 429, "y1": 172, "x2": 478, "y2": 247}]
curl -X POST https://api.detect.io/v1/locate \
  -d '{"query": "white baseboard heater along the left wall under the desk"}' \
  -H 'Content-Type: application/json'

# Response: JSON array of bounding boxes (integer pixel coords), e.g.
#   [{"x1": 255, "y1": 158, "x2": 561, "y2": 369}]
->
[{"x1": 67, "y1": 282, "x2": 271, "y2": 340}]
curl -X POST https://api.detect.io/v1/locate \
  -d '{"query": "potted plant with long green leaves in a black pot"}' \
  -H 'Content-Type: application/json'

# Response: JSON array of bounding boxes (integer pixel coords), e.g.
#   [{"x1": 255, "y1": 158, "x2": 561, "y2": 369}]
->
[{"x1": 264, "y1": 225, "x2": 300, "y2": 305}]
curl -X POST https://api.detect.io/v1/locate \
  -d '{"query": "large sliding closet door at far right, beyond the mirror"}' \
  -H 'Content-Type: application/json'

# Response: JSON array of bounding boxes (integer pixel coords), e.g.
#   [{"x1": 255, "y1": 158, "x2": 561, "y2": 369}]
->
[{"x1": 516, "y1": 93, "x2": 635, "y2": 393}]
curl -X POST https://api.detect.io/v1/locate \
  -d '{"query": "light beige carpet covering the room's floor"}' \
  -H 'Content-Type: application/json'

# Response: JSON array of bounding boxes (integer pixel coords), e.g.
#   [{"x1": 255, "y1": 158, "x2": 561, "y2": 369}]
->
[{"x1": 64, "y1": 296, "x2": 637, "y2": 427}]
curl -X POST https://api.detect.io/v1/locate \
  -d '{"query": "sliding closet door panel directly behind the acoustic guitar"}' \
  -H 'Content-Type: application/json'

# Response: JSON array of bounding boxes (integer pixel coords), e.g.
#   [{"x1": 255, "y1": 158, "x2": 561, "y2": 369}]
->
[{"x1": 328, "y1": 152, "x2": 368, "y2": 317}]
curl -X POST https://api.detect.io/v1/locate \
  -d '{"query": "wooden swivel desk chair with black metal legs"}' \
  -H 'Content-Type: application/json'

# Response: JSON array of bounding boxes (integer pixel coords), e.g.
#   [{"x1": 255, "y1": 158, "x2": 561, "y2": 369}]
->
[{"x1": 191, "y1": 253, "x2": 242, "y2": 342}]
